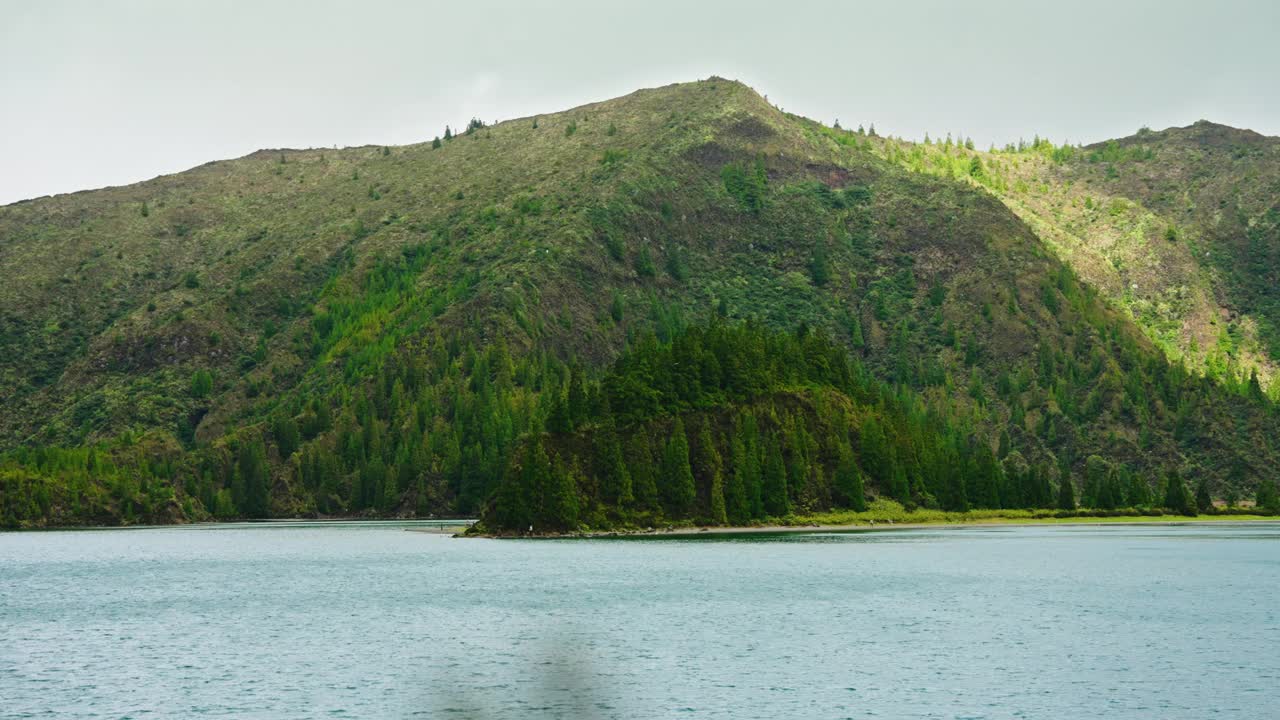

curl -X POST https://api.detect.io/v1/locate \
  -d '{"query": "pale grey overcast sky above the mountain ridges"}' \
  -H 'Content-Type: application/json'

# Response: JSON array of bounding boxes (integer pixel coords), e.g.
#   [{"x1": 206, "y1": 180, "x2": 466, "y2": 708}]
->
[{"x1": 0, "y1": 0, "x2": 1280, "y2": 204}]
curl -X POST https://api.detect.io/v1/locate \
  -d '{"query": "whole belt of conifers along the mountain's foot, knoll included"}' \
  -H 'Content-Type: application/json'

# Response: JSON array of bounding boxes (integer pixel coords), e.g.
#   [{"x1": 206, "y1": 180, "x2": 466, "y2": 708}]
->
[{"x1": 0, "y1": 310, "x2": 1280, "y2": 530}]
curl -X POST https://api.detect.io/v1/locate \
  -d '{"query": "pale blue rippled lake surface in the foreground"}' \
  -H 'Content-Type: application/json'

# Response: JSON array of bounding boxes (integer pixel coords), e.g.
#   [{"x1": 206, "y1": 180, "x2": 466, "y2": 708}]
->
[{"x1": 0, "y1": 523, "x2": 1280, "y2": 720}]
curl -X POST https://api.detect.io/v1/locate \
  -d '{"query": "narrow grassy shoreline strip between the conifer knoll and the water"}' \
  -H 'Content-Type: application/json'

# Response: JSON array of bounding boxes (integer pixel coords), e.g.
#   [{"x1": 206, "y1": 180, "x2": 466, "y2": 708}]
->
[{"x1": 468, "y1": 515, "x2": 1280, "y2": 539}]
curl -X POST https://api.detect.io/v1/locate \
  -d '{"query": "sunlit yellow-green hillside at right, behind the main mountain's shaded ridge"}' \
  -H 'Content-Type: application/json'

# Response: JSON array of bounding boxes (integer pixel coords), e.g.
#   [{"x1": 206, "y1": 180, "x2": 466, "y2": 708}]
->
[{"x1": 876, "y1": 120, "x2": 1280, "y2": 386}]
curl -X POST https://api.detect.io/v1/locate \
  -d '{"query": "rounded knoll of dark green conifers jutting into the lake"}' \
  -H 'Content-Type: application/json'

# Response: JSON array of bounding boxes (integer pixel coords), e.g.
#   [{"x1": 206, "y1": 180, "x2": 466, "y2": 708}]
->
[{"x1": 486, "y1": 322, "x2": 1269, "y2": 532}]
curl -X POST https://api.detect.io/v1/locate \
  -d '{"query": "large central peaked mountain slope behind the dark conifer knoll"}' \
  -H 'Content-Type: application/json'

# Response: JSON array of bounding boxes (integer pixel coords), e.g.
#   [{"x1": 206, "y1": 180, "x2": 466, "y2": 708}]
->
[{"x1": 0, "y1": 78, "x2": 1276, "y2": 521}]
